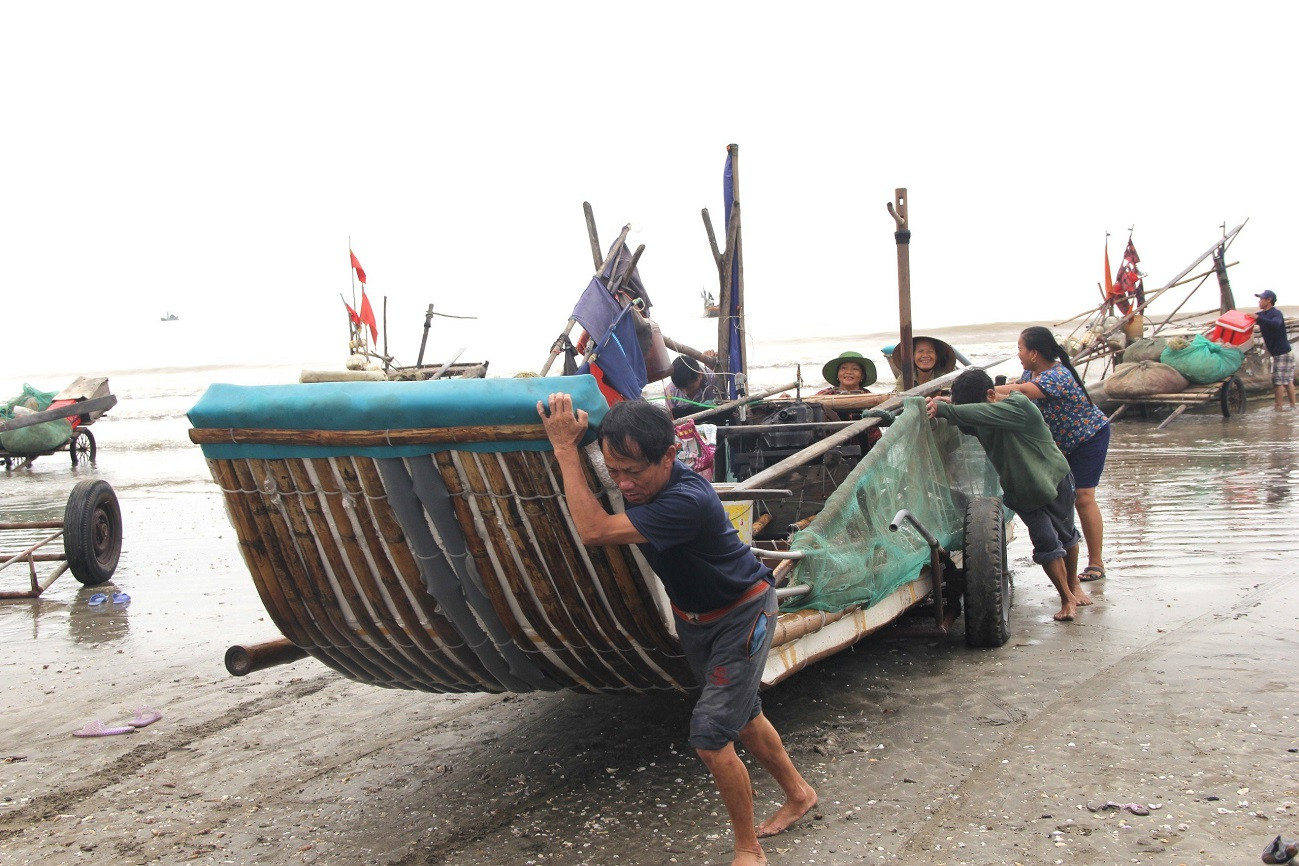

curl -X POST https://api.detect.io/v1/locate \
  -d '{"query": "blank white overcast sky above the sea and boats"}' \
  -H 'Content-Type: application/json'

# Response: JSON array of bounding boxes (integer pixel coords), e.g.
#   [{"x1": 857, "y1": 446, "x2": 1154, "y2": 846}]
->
[{"x1": 0, "y1": 1, "x2": 1299, "y2": 373}]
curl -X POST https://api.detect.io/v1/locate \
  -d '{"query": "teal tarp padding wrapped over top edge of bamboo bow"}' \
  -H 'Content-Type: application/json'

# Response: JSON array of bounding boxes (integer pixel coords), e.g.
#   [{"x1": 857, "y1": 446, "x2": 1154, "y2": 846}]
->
[{"x1": 188, "y1": 375, "x2": 608, "y2": 460}]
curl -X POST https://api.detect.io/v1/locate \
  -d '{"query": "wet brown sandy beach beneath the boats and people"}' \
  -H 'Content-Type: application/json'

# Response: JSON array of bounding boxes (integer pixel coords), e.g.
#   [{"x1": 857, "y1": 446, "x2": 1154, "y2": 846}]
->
[{"x1": 0, "y1": 402, "x2": 1299, "y2": 866}]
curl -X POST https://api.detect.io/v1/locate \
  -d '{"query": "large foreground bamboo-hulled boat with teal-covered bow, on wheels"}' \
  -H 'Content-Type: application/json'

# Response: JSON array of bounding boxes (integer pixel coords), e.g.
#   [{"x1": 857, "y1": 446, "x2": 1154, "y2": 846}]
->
[{"x1": 190, "y1": 145, "x2": 1012, "y2": 693}]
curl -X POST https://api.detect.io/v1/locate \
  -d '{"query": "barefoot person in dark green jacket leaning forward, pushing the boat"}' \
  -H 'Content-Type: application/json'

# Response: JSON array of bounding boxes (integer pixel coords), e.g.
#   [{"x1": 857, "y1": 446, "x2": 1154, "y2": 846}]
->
[{"x1": 926, "y1": 370, "x2": 1091, "y2": 622}]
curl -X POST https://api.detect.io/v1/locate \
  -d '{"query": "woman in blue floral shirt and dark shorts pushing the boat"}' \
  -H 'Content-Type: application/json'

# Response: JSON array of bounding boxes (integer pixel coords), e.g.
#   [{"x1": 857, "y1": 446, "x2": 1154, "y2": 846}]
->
[{"x1": 996, "y1": 326, "x2": 1109, "y2": 580}]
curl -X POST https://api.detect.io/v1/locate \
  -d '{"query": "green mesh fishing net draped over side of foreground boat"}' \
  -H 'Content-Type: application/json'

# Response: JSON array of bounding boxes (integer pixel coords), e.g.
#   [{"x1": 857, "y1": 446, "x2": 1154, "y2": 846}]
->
[{"x1": 781, "y1": 397, "x2": 1002, "y2": 612}]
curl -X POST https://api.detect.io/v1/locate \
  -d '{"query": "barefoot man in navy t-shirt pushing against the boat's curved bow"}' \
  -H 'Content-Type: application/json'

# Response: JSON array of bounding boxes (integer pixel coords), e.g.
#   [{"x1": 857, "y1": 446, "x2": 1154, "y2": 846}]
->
[{"x1": 536, "y1": 393, "x2": 817, "y2": 866}]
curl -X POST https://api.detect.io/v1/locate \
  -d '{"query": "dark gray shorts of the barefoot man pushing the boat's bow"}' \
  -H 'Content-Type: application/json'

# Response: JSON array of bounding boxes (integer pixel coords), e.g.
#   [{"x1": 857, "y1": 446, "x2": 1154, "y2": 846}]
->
[{"x1": 677, "y1": 587, "x2": 777, "y2": 750}]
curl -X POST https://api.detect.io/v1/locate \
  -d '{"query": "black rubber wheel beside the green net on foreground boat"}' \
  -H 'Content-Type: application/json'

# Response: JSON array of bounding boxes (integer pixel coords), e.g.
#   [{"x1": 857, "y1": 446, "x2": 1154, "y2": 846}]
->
[{"x1": 964, "y1": 496, "x2": 1015, "y2": 647}]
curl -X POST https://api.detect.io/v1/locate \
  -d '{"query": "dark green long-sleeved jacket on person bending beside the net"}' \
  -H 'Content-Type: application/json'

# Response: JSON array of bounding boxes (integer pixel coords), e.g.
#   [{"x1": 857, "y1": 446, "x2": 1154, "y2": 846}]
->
[{"x1": 938, "y1": 391, "x2": 1069, "y2": 512}]
